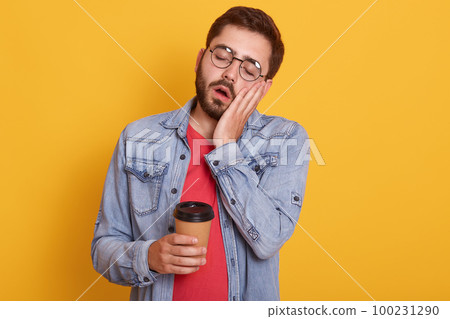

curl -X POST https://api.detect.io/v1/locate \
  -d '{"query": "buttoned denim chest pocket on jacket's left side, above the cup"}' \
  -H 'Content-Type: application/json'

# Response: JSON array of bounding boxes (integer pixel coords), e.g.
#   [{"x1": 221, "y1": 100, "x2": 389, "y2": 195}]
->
[{"x1": 125, "y1": 159, "x2": 169, "y2": 216}]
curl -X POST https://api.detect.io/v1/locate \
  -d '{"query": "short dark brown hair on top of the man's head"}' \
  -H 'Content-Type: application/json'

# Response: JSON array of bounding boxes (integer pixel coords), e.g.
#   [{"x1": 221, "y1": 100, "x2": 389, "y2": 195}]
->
[{"x1": 206, "y1": 7, "x2": 284, "y2": 79}]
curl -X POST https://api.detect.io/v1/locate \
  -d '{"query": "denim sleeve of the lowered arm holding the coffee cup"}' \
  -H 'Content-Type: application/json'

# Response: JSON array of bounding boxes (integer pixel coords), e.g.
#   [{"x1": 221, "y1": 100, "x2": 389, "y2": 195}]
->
[{"x1": 91, "y1": 131, "x2": 157, "y2": 287}]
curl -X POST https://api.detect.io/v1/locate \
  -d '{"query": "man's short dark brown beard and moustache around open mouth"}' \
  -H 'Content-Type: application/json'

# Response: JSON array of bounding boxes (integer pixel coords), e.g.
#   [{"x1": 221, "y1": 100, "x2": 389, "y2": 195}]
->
[{"x1": 195, "y1": 57, "x2": 236, "y2": 121}]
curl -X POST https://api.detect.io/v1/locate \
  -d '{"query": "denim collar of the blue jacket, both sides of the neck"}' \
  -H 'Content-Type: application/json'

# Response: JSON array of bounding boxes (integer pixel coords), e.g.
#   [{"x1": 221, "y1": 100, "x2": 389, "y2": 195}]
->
[{"x1": 160, "y1": 96, "x2": 264, "y2": 138}]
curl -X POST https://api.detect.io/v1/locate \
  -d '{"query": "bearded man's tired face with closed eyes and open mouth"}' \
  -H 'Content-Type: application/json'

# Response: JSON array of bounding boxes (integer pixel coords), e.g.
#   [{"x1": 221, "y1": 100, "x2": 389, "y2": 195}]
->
[{"x1": 195, "y1": 25, "x2": 272, "y2": 120}]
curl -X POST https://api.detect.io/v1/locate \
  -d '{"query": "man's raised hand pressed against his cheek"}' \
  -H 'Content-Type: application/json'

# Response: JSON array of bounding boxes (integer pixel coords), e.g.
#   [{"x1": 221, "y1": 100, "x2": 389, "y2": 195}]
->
[{"x1": 213, "y1": 81, "x2": 269, "y2": 147}]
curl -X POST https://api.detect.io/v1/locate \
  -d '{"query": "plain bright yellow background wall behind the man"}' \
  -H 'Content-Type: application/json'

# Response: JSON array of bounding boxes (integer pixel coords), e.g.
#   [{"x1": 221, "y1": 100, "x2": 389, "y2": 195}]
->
[{"x1": 0, "y1": 0, "x2": 450, "y2": 300}]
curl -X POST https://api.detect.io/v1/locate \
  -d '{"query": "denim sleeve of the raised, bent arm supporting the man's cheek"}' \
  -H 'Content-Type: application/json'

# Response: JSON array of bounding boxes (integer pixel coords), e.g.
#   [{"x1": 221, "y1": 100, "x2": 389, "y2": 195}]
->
[{"x1": 205, "y1": 122, "x2": 310, "y2": 259}]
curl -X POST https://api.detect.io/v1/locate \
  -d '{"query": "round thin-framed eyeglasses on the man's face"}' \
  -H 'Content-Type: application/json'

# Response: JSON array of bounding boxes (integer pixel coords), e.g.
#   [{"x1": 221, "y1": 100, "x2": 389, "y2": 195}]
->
[{"x1": 209, "y1": 46, "x2": 264, "y2": 82}]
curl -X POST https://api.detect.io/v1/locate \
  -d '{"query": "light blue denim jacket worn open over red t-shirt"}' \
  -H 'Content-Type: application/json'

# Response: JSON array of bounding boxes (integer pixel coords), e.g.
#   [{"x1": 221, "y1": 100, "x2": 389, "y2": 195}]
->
[{"x1": 91, "y1": 98, "x2": 310, "y2": 300}]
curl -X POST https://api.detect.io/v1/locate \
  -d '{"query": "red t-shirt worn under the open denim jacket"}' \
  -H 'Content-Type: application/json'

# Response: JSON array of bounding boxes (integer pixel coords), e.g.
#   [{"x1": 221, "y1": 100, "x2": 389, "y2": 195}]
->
[{"x1": 172, "y1": 125, "x2": 228, "y2": 301}]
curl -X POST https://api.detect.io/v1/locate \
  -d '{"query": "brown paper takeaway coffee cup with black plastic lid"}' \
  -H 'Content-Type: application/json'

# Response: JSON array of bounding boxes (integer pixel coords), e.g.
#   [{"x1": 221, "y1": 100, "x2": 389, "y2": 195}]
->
[{"x1": 173, "y1": 201, "x2": 214, "y2": 256}]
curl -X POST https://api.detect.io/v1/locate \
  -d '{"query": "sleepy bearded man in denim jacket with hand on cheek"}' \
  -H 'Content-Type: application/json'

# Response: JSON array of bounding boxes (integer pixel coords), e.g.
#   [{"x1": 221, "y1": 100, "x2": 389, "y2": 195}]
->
[{"x1": 91, "y1": 7, "x2": 309, "y2": 300}]
